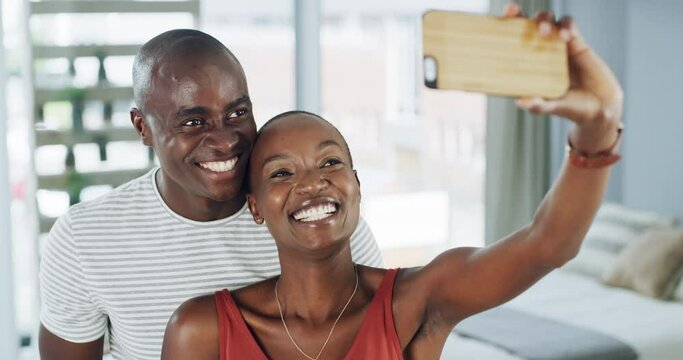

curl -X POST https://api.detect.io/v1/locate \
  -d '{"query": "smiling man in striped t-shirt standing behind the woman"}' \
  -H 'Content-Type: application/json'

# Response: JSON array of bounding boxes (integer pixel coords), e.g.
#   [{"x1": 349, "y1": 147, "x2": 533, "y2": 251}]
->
[{"x1": 40, "y1": 30, "x2": 381, "y2": 359}]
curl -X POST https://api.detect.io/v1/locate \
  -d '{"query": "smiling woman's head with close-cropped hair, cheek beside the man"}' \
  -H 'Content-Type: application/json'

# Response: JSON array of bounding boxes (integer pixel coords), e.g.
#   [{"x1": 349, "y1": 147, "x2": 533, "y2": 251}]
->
[{"x1": 248, "y1": 114, "x2": 360, "y2": 255}]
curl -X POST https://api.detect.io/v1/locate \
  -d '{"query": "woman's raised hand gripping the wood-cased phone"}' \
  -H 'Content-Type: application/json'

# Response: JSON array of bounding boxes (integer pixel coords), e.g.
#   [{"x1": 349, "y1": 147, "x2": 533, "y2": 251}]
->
[{"x1": 505, "y1": 3, "x2": 623, "y2": 152}]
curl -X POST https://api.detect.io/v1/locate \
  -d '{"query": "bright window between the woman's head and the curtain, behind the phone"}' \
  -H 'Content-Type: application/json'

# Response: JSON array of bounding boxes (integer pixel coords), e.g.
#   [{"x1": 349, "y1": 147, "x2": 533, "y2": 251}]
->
[{"x1": 320, "y1": 0, "x2": 488, "y2": 267}]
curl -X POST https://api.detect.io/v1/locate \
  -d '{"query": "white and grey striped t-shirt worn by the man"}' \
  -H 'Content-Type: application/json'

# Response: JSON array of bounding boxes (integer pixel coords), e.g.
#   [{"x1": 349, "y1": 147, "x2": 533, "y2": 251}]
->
[{"x1": 40, "y1": 169, "x2": 382, "y2": 360}]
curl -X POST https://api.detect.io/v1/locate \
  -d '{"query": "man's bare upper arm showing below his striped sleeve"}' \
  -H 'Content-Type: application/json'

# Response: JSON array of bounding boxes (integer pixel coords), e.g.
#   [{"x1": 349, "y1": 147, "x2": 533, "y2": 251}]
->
[{"x1": 38, "y1": 324, "x2": 104, "y2": 360}]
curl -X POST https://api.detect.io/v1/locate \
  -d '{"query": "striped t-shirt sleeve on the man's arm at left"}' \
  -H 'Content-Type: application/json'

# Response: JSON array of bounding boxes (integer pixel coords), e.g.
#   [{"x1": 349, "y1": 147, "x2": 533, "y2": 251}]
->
[{"x1": 40, "y1": 213, "x2": 108, "y2": 343}]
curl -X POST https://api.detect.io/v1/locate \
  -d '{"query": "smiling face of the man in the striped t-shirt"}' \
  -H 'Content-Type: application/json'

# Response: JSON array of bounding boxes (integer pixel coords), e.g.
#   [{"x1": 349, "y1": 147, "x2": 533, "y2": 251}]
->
[{"x1": 144, "y1": 56, "x2": 256, "y2": 202}]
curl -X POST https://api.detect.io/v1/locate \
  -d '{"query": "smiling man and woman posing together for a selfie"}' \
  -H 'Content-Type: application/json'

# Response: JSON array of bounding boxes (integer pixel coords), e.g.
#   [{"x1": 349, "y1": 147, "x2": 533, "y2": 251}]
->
[{"x1": 41, "y1": 5, "x2": 622, "y2": 359}]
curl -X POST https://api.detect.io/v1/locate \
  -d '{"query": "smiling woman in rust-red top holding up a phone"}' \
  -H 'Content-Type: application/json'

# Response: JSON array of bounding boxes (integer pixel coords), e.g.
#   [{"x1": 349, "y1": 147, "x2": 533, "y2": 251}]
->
[{"x1": 162, "y1": 8, "x2": 622, "y2": 359}]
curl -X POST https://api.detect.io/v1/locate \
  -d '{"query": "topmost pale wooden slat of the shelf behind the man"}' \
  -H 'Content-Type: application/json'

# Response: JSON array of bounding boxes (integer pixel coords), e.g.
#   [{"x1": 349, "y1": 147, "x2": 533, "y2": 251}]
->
[{"x1": 29, "y1": 0, "x2": 199, "y2": 15}]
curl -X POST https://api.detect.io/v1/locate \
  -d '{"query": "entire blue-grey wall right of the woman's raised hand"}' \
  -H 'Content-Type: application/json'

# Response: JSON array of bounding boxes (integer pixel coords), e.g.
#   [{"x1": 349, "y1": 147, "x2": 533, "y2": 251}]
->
[{"x1": 554, "y1": 0, "x2": 683, "y2": 220}]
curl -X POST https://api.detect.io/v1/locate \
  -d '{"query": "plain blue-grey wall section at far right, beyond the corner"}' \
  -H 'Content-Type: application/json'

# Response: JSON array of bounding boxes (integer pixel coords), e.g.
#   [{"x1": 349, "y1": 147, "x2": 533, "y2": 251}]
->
[{"x1": 623, "y1": 0, "x2": 683, "y2": 220}]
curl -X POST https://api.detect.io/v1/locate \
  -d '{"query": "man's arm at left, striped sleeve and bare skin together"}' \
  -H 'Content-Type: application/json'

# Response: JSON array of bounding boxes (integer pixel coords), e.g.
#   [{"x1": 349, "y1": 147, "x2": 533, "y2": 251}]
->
[{"x1": 38, "y1": 213, "x2": 107, "y2": 359}]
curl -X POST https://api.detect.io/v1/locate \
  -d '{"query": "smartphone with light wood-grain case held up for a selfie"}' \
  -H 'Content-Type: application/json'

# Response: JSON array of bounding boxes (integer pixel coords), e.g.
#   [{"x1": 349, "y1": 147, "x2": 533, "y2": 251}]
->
[{"x1": 422, "y1": 10, "x2": 569, "y2": 98}]
